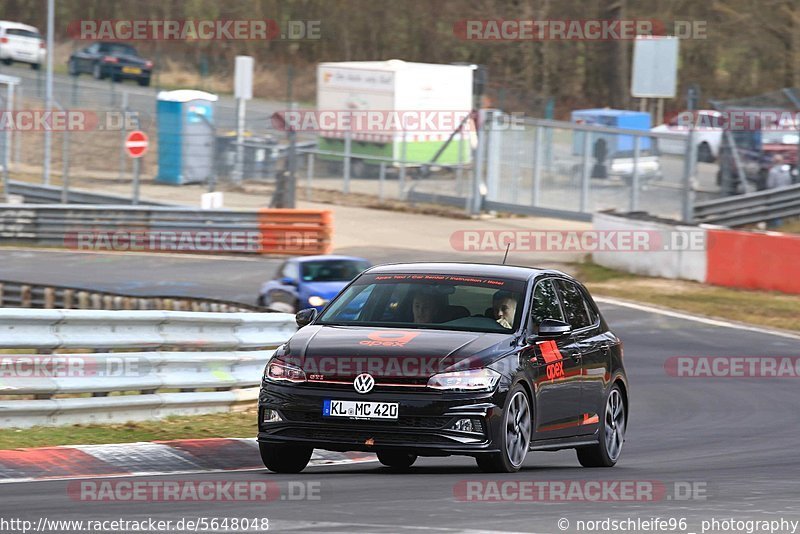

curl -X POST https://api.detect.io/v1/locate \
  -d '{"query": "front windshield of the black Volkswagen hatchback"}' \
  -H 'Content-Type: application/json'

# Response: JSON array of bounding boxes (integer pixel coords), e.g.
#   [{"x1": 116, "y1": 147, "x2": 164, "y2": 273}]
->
[{"x1": 317, "y1": 273, "x2": 525, "y2": 333}]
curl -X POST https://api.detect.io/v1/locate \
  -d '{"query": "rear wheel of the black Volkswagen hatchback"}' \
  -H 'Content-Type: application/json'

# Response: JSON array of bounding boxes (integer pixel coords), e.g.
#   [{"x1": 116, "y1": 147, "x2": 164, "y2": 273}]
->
[{"x1": 575, "y1": 384, "x2": 628, "y2": 467}]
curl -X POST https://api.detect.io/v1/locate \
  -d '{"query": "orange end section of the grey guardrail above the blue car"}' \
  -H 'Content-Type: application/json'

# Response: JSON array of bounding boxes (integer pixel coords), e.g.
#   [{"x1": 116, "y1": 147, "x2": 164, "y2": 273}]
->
[{"x1": 258, "y1": 208, "x2": 333, "y2": 256}]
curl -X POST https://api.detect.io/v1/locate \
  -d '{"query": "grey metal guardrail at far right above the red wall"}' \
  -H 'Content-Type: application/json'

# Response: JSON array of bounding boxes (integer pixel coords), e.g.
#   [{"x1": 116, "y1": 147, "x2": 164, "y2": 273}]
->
[{"x1": 694, "y1": 184, "x2": 800, "y2": 226}]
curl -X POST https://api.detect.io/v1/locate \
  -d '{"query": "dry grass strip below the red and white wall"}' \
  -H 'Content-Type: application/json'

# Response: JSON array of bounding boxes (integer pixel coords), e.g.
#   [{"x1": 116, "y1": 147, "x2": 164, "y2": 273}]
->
[{"x1": 570, "y1": 263, "x2": 800, "y2": 332}]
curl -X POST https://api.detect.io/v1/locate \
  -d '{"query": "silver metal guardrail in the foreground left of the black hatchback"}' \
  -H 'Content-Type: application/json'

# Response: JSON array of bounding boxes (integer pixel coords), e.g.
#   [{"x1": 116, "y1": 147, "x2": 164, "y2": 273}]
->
[{"x1": 0, "y1": 309, "x2": 296, "y2": 427}]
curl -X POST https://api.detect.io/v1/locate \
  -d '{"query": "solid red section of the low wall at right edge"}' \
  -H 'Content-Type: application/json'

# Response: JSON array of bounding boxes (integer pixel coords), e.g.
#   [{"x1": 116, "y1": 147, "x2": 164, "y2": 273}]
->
[{"x1": 706, "y1": 229, "x2": 800, "y2": 294}]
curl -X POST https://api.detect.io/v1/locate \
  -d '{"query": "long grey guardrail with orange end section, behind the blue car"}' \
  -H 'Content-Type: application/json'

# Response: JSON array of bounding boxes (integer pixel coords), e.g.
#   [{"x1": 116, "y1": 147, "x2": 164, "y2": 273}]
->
[{"x1": 0, "y1": 204, "x2": 333, "y2": 255}]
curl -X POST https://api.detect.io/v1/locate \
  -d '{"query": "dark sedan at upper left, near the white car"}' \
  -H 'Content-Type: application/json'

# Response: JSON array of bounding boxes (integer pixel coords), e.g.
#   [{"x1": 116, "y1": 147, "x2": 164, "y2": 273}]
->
[{"x1": 67, "y1": 43, "x2": 153, "y2": 86}]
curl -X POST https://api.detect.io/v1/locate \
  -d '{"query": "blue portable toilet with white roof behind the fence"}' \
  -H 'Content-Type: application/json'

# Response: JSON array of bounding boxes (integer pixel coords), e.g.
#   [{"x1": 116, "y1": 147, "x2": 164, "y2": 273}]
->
[{"x1": 156, "y1": 89, "x2": 217, "y2": 185}]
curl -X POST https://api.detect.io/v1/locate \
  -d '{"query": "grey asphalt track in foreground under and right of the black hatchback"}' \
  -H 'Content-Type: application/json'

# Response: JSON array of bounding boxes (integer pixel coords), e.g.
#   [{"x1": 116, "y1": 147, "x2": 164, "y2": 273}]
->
[{"x1": 0, "y1": 304, "x2": 800, "y2": 533}]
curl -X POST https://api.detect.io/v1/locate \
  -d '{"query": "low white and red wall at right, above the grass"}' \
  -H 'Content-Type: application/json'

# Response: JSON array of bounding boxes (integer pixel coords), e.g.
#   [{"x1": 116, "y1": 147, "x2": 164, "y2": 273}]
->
[{"x1": 592, "y1": 213, "x2": 800, "y2": 294}]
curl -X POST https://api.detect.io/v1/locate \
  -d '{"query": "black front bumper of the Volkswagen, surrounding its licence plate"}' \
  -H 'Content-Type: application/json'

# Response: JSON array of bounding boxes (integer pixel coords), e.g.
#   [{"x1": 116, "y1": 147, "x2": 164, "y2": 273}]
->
[{"x1": 258, "y1": 383, "x2": 505, "y2": 456}]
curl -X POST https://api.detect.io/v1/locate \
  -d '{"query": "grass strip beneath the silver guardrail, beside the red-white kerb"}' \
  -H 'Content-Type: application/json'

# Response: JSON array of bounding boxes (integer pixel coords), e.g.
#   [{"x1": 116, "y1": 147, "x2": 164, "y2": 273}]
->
[{"x1": 0, "y1": 408, "x2": 258, "y2": 449}]
